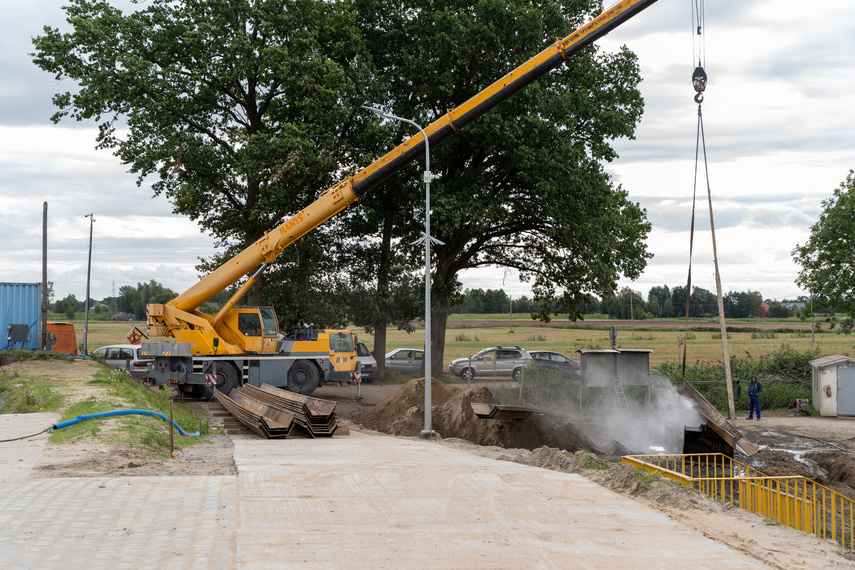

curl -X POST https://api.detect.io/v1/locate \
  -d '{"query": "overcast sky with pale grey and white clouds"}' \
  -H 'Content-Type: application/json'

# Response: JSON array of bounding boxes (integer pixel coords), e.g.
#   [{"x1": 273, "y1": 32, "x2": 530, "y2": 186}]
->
[{"x1": 0, "y1": 0, "x2": 855, "y2": 306}]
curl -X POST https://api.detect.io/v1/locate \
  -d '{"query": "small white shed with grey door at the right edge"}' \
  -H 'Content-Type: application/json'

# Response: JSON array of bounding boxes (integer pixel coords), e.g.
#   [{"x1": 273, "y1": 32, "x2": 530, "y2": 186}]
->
[{"x1": 810, "y1": 354, "x2": 855, "y2": 416}]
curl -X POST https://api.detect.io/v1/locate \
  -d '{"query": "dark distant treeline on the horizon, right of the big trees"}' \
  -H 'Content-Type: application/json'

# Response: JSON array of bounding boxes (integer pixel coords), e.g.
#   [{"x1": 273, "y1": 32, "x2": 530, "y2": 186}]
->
[{"x1": 451, "y1": 285, "x2": 810, "y2": 320}]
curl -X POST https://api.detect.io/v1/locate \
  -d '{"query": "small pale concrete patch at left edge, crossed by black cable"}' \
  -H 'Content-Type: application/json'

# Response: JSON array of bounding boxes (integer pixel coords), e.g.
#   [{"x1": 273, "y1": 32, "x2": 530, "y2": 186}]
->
[{"x1": 0, "y1": 413, "x2": 59, "y2": 481}]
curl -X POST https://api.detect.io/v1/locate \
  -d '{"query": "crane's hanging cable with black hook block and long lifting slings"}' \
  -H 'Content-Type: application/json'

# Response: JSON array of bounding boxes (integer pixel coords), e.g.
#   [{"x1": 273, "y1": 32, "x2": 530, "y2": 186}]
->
[{"x1": 682, "y1": 0, "x2": 736, "y2": 427}]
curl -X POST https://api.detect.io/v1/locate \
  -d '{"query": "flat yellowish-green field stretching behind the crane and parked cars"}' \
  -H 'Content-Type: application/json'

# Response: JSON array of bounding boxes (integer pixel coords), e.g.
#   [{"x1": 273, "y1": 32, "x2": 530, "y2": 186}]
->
[{"x1": 58, "y1": 315, "x2": 855, "y2": 368}]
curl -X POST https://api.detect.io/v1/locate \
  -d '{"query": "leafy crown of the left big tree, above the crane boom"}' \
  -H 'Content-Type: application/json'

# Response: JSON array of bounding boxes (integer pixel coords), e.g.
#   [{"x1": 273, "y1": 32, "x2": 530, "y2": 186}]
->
[{"x1": 32, "y1": 0, "x2": 368, "y2": 304}]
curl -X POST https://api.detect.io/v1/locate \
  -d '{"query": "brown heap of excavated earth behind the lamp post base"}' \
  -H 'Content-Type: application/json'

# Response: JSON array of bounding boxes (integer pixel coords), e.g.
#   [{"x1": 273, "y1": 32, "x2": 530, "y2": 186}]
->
[{"x1": 354, "y1": 378, "x2": 593, "y2": 451}]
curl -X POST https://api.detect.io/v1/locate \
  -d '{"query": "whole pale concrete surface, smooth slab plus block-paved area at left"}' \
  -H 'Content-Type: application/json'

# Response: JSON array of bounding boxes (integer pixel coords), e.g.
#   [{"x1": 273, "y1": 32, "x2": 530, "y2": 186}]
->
[{"x1": 0, "y1": 414, "x2": 759, "y2": 570}]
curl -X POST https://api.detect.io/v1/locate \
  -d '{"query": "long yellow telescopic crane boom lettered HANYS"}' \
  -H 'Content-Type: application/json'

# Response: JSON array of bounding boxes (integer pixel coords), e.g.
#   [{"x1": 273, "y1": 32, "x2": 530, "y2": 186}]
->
[{"x1": 167, "y1": 0, "x2": 656, "y2": 311}]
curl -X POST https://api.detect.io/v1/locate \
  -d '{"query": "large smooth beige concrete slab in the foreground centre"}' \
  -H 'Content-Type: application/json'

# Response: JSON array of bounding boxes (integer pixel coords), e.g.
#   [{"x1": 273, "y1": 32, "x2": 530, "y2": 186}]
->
[{"x1": 235, "y1": 432, "x2": 759, "y2": 570}]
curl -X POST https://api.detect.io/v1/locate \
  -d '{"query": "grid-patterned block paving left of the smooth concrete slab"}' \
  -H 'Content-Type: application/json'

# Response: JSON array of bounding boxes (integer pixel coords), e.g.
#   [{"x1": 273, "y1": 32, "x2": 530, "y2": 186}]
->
[{"x1": 0, "y1": 476, "x2": 237, "y2": 569}]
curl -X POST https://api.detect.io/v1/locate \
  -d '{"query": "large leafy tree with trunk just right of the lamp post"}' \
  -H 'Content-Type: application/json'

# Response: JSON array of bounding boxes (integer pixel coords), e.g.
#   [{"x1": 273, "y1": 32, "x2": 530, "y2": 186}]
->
[{"x1": 354, "y1": 0, "x2": 650, "y2": 374}]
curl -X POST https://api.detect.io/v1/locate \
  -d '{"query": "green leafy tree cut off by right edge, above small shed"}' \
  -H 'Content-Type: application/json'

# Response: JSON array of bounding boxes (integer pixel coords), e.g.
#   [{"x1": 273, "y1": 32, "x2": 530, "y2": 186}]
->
[{"x1": 792, "y1": 170, "x2": 855, "y2": 328}]
